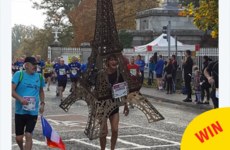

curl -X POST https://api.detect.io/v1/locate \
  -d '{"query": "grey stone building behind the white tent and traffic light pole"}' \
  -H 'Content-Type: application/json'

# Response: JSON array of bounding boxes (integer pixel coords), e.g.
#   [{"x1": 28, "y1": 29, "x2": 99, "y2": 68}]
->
[{"x1": 130, "y1": 0, "x2": 217, "y2": 47}]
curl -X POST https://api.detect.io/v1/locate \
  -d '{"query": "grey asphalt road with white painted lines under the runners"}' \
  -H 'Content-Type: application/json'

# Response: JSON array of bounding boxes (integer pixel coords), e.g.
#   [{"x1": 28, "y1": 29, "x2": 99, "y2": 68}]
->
[{"x1": 12, "y1": 83, "x2": 205, "y2": 150}]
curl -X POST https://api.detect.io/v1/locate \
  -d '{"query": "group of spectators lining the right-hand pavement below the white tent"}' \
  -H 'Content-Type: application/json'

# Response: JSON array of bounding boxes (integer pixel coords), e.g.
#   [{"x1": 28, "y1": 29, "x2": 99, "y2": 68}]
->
[{"x1": 124, "y1": 50, "x2": 219, "y2": 108}]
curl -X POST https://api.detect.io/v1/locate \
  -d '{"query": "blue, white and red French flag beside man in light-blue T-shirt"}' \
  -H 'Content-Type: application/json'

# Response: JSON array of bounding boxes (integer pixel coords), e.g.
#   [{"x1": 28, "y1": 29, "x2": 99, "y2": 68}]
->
[{"x1": 41, "y1": 116, "x2": 65, "y2": 150}]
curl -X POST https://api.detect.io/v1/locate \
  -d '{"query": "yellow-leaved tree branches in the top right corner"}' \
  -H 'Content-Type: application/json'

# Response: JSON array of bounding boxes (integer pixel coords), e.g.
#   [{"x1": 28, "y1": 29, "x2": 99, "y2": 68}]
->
[{"x1": 179, "y1": 0, "x2": 219, "y2": 38}]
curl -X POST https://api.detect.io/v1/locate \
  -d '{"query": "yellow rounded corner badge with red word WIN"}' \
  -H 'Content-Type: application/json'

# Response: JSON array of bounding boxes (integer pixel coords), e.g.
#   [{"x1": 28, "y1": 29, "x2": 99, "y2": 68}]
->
[{"x1": 181, "y1": 107, "x2": 230, "y2": 150}]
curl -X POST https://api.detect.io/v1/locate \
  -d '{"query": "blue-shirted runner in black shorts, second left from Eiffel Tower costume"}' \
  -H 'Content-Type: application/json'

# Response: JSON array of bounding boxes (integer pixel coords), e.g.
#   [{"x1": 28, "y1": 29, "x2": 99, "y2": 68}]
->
[{"x1": 55, "y1": 59, "x2": 70, "y2": 101}]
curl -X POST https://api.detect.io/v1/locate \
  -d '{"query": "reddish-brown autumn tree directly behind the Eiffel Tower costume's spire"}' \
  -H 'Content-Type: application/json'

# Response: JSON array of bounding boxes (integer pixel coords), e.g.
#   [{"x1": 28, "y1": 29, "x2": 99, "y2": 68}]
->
[{"x1": 68, "y1": 0, "x2": 159, "y2": 46}]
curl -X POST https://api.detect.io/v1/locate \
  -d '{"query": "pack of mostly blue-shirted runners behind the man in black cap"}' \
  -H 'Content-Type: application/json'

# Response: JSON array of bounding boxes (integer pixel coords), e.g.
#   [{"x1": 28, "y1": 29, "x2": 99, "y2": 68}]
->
[{"x1": 12, "y1": 55, "x2": 87, "y2": 101}]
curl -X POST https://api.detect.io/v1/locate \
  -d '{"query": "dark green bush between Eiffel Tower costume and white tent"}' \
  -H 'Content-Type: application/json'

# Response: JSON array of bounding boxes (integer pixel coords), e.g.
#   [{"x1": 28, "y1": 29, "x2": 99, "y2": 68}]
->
[{"x1": 118, "y1": 30, "x2": 133, "y2": 48}]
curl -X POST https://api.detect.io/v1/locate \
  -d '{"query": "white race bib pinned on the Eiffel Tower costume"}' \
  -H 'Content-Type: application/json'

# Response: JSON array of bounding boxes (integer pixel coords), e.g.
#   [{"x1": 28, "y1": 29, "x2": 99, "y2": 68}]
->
[{"x1": 112, "y1": 82, "x2": 128, "y2": 98}]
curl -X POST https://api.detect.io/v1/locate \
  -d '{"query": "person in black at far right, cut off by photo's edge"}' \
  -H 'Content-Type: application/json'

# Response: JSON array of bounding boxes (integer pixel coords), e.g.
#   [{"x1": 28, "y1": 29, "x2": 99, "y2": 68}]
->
[{"x1": 204, "y1": 60, "x2": 219, "y2": 108}]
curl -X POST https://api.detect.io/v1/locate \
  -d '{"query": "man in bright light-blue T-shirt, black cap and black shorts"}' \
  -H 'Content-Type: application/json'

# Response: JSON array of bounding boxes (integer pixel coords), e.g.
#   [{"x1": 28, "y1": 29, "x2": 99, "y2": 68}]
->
[{"x1": 12, "y1": 57, "x2": 45, "y2": 150}]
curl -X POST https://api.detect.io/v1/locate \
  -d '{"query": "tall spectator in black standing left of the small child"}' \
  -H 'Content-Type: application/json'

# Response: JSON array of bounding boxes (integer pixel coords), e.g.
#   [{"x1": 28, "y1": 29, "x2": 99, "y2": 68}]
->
[{"x1": 181, "y1": 50, "x2": 193, "y2": 102}]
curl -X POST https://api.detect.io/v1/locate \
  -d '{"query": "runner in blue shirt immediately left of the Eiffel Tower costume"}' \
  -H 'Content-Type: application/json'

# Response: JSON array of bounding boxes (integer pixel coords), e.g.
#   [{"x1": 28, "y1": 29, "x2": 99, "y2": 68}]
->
[{"x1": 68, "y1": 56, "x2": 81, "y2": 92}]
